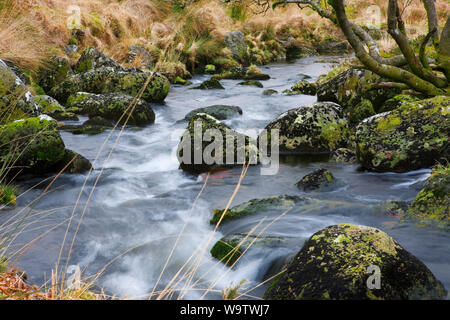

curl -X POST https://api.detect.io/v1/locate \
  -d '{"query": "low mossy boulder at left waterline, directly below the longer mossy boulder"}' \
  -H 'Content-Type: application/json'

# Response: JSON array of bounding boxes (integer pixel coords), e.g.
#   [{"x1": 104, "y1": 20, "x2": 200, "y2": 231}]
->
[{"x1": 67, "y1": 92, "x2": 155, "y2": 126}]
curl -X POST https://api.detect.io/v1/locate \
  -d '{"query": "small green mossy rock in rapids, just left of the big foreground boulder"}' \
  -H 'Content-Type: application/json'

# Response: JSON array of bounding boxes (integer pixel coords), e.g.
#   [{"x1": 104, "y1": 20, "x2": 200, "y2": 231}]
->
[{"x1": 210, "y1": 233, "x2": 284, "y2": 266}]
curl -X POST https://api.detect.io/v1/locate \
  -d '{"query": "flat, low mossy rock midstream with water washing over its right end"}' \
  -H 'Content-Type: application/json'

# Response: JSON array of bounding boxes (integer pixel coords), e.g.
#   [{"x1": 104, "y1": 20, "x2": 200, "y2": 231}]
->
[{"x1": 210, "y1": 195, "x2": 318, "y2": 224}]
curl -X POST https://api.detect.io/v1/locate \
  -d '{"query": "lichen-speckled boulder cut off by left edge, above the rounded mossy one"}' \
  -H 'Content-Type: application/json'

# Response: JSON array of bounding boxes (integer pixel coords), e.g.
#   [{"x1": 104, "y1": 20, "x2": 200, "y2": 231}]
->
[{"x1": 0, "y1": 59, "x2": 40, "y2": 123}]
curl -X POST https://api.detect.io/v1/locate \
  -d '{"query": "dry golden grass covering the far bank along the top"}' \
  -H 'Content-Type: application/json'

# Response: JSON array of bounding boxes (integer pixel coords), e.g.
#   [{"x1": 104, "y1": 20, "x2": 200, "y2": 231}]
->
[{"x1": 0, "y1": 0, "x2": 450, "y2": 69}]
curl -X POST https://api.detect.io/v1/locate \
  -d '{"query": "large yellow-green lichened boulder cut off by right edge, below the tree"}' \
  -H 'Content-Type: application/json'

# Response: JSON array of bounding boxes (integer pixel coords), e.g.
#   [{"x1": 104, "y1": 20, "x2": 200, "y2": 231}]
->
[{"x1": 356, "y1": 97, "x2": 450, "y2": 172}]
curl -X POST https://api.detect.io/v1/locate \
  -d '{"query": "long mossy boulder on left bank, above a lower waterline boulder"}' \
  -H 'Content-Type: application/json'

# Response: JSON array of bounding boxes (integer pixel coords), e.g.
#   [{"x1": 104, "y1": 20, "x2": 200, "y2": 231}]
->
[{"x1": 50, "y1": 67, "x2": 170, "y2": 104}]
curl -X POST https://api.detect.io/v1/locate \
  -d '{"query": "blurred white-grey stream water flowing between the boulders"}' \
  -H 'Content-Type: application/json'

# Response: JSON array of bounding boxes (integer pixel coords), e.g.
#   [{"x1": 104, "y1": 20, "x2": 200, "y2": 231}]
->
[{"x1": 0, "y1": 58, "x2": 450, "y2": 299}]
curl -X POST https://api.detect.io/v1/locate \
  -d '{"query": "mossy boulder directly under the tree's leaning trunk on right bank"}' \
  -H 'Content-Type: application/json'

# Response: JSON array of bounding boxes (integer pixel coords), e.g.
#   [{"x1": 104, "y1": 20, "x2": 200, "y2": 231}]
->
[{"x1": 317, "y1": 68, "x2": 400, "y2": 111}]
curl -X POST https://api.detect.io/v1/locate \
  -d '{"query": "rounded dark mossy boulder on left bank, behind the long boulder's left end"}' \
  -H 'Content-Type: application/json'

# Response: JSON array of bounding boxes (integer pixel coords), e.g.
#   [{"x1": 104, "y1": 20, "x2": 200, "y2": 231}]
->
[{"x1": 37, "y1": 56, "x2": 73, "y2": 92}]
